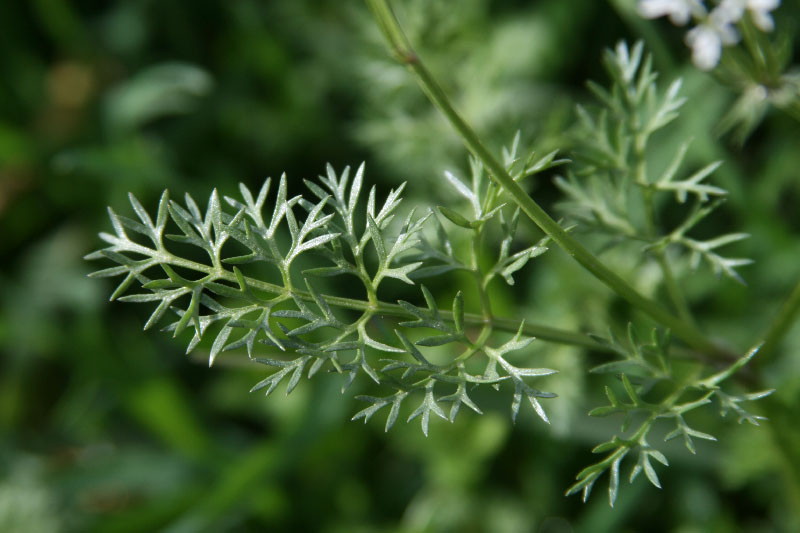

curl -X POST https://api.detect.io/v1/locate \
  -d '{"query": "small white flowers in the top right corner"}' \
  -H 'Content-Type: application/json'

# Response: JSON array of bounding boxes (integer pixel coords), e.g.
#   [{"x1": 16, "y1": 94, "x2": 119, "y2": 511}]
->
[{"x1": 638, "y1": 0, "x2": 781, "y2": 70}]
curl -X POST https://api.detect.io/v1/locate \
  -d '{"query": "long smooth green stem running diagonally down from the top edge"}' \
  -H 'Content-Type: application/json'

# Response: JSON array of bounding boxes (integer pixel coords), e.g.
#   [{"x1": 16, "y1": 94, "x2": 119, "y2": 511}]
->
[{"x1": 367, "y1": 0, "x2": 721, "y2": 354}]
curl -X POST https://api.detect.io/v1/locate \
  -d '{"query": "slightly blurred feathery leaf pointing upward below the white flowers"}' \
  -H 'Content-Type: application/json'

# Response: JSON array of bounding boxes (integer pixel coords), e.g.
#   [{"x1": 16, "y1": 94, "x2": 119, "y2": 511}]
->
[{"x1": 556, "y1": 42, "x2": 752, "y2": 283}]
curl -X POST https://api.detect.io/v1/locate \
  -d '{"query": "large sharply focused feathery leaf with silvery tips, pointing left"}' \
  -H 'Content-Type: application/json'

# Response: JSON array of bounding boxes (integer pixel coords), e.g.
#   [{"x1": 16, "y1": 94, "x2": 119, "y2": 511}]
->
[{"x1": 87, "y1": 156, "x2": 555, "y2": 434}]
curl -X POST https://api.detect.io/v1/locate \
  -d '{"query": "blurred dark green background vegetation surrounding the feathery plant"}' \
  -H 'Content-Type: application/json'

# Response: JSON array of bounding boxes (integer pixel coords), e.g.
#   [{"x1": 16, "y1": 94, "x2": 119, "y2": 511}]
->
[{"x1": 0, "y1": 0, "x2": 800, "y2": 533}]
